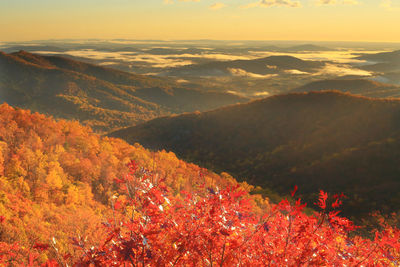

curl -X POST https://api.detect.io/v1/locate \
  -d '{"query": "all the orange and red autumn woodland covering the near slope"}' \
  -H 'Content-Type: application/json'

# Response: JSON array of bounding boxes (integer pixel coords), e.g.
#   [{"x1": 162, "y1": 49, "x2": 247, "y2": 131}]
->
[{"x1": 0, "y1": 104, "x2": 400, "y2": 266}]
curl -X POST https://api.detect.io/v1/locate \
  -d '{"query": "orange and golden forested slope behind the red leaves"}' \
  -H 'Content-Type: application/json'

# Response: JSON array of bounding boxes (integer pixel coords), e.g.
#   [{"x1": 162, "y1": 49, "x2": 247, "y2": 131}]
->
[{"x1": 0, "y1": 104, "x2": 268, "y2": 265}]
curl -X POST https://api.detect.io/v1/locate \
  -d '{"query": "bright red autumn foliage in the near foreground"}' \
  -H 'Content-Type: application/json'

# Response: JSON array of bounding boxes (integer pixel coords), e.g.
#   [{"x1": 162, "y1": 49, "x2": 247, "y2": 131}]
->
[{"x1": 0, "y1": 162, "x2": 400, "y2": 266}]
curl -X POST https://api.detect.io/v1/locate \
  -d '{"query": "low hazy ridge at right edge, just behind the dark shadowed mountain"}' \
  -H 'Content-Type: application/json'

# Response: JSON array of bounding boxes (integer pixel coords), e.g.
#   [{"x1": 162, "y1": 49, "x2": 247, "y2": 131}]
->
[{"x1": 292, "y1": 79, "x2": 400, "y2": 98}]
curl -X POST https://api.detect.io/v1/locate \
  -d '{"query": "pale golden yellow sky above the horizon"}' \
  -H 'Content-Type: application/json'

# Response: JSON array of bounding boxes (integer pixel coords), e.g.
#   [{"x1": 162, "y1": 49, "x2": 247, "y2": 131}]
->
[{"x1": 0, "y1": 0, "x2": 400, "y2": 42}]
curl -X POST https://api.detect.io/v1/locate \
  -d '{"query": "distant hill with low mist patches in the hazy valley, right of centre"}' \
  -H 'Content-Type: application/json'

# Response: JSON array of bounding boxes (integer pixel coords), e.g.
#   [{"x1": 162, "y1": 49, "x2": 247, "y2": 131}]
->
[{"x1": 165, "y1": 56, "x2": 325, "y2": 76}]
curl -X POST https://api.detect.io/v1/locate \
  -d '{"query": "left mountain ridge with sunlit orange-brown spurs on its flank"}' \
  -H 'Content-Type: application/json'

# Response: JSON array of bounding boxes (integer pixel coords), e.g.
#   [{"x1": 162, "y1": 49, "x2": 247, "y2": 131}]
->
[{"x1": 0, "y1": 51, "x2": 248, "y2": 131}]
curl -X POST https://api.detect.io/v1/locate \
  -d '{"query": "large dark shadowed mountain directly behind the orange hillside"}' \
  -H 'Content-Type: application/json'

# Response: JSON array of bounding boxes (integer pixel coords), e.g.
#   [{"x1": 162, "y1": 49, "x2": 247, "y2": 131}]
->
[{"x1": 111, "y1": 91, "x2": 400, "y2": 221}]
